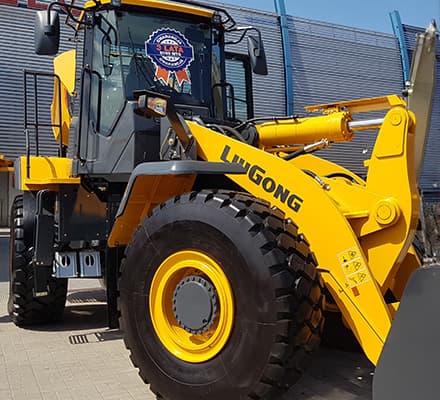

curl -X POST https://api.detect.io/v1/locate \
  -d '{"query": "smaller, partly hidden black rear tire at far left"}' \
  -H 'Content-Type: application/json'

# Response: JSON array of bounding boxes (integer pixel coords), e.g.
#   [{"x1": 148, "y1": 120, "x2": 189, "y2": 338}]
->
[{"x1": 8, "y1": 196, "x2": 67, "y2": 326}]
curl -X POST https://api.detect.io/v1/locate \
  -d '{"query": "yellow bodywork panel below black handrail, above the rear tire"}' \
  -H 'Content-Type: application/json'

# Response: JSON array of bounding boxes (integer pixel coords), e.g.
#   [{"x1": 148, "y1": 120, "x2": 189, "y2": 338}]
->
[{"x1": 16, "y1": 156, "x2": 81, "y2": 190}]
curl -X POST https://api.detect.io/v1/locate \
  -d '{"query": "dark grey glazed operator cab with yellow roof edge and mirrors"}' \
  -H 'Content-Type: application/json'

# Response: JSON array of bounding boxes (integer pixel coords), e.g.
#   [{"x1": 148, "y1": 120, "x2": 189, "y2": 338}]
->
[{"x1": 36, "y1": 0, "x2": 267, "y2": 178}]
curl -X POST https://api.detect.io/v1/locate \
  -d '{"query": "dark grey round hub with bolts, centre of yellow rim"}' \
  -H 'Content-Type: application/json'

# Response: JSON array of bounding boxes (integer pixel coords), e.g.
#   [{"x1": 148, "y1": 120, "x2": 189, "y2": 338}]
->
[{"x1": 173, "y1": 275, "x2": 217, "y2": 335}]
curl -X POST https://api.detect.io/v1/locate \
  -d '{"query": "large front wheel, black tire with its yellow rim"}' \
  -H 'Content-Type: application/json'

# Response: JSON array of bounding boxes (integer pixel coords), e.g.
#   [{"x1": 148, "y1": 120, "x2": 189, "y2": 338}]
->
[{"x1": 120, "y1": 191, "x2": 324, "y2": 400}]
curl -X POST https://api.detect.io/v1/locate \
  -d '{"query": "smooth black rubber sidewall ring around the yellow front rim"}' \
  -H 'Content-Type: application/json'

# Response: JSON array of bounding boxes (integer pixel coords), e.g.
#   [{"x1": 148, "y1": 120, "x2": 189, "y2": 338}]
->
[{"x1": 121, "y1": 194, "x2": 294, "y2": 400}]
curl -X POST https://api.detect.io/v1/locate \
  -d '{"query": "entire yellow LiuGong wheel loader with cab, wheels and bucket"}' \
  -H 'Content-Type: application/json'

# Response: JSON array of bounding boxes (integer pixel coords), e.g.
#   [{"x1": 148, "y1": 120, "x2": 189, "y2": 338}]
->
[{"x1": 9, "y1": 0, "x2": 440, "y2": 400}]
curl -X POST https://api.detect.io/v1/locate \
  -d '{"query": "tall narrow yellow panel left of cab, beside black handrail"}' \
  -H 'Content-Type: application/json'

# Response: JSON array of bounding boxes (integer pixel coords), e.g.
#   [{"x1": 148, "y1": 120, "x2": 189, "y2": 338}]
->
[{"x1": 50, "y1": 50, "x2": 76, "y2": 146}]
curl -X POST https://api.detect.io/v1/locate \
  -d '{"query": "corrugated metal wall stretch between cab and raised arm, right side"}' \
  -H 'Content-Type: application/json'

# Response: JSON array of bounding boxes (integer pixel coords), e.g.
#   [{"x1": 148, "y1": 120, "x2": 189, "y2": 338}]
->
[{"x1": 217, "y1": 3, "x2": 403, "y2": 175}]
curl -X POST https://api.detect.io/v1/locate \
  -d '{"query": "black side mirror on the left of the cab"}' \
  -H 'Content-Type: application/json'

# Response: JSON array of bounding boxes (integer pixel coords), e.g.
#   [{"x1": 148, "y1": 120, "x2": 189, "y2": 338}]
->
[{"x1": 34, "y1": 10, "x2": 60, "y2": 56}]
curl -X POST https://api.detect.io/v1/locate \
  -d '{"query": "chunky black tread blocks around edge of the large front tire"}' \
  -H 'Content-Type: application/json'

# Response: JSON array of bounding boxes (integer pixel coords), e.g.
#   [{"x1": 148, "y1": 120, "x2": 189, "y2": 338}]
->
[{"x1": 119, "y1": 190, "x2": 325, "y2": 400}]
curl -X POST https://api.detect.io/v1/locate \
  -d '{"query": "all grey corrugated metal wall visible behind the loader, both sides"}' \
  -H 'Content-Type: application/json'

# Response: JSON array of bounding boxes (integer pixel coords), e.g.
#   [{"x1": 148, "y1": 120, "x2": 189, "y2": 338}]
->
[{"x1": 0, "y1": 1, "x2": 434, "y2": 184}]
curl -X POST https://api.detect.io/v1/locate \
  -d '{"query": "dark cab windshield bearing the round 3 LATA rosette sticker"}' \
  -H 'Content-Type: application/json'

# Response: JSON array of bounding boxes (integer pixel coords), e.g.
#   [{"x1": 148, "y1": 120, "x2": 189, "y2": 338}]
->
[{"x1": 112, "y1": 11, "x2": 220, "y2": 105}]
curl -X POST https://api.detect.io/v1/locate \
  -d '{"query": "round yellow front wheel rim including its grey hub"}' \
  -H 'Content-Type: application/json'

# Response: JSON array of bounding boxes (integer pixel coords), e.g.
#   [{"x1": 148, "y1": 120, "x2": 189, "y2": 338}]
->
[{"x1": 148, "y1": 250, "x2": 235, "y2": 363}]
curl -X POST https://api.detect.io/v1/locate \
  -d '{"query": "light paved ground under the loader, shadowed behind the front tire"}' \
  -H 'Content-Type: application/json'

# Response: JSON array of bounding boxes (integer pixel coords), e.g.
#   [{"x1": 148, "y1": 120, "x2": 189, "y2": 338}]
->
[{"x1": 0, "y1": 233, "x2": 373, "y2": 400}]
